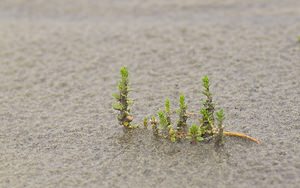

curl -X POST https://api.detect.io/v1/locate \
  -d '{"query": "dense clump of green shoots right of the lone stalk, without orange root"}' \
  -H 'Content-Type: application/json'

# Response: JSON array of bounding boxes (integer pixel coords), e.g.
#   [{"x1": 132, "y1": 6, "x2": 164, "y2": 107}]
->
[{"x1": 146, "y1": 76, "x2": 224, "y2": 145}]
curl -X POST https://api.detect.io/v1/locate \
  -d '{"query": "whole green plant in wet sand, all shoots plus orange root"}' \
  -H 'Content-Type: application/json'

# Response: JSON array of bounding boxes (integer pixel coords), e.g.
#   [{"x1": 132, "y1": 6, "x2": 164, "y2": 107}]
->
[{"x1": 113, "y1": 67, "x2": 259, "y2": 146}]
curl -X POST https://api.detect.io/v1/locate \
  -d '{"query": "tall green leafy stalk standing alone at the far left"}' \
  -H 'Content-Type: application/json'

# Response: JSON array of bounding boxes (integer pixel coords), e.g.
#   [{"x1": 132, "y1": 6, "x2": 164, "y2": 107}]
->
[{"x1": 113, "y1": 67, "x2": 133, "y2": 128}]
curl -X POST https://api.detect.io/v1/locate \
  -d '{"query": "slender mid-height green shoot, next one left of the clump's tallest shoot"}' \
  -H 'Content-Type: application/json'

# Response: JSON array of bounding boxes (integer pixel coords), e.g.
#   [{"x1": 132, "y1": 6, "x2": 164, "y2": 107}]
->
[{"x1": 177, "y1": 94, "x2": 188, "y2": 131}]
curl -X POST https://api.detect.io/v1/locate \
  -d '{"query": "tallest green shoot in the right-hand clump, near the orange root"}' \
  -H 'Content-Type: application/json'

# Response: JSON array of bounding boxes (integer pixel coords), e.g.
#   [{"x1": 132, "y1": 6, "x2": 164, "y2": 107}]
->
[{"x1": 200, "y1": 76, "x2": 215, "y2": 131}]
